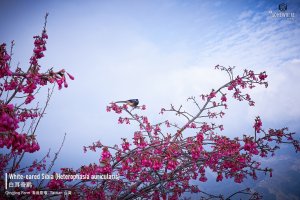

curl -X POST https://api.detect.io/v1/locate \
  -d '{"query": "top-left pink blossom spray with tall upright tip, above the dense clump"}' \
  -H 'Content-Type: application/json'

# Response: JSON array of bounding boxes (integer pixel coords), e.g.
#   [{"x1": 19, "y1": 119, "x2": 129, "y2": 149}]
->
[{"x1": 0, "y1": 16, "x2": 74, "y2": 104}]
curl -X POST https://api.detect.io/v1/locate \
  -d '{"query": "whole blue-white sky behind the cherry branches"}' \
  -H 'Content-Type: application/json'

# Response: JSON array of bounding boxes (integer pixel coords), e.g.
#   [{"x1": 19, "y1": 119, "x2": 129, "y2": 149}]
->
[{"x1": 0, "y1": 0, "x2": 300, "y2": 199}]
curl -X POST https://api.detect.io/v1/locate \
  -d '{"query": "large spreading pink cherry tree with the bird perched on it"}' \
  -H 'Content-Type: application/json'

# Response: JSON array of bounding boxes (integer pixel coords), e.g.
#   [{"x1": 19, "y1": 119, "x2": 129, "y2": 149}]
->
[{"x1": 52, "y1": 65, "x2": 299, "y2": 199}]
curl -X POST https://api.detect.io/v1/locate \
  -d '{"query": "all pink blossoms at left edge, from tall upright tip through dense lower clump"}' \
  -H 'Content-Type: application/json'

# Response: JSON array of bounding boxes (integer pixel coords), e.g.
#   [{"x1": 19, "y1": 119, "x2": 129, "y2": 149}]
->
[{"x1": 0, "y1": 15, "x2": 74, "y2": 153}]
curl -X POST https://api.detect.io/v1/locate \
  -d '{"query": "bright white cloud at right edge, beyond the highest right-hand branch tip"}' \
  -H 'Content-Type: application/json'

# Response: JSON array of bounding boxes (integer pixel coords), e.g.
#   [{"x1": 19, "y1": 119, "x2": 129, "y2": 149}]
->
[{"x1": 249, "y1": 62, "x2": 300, "y2": 122}]
